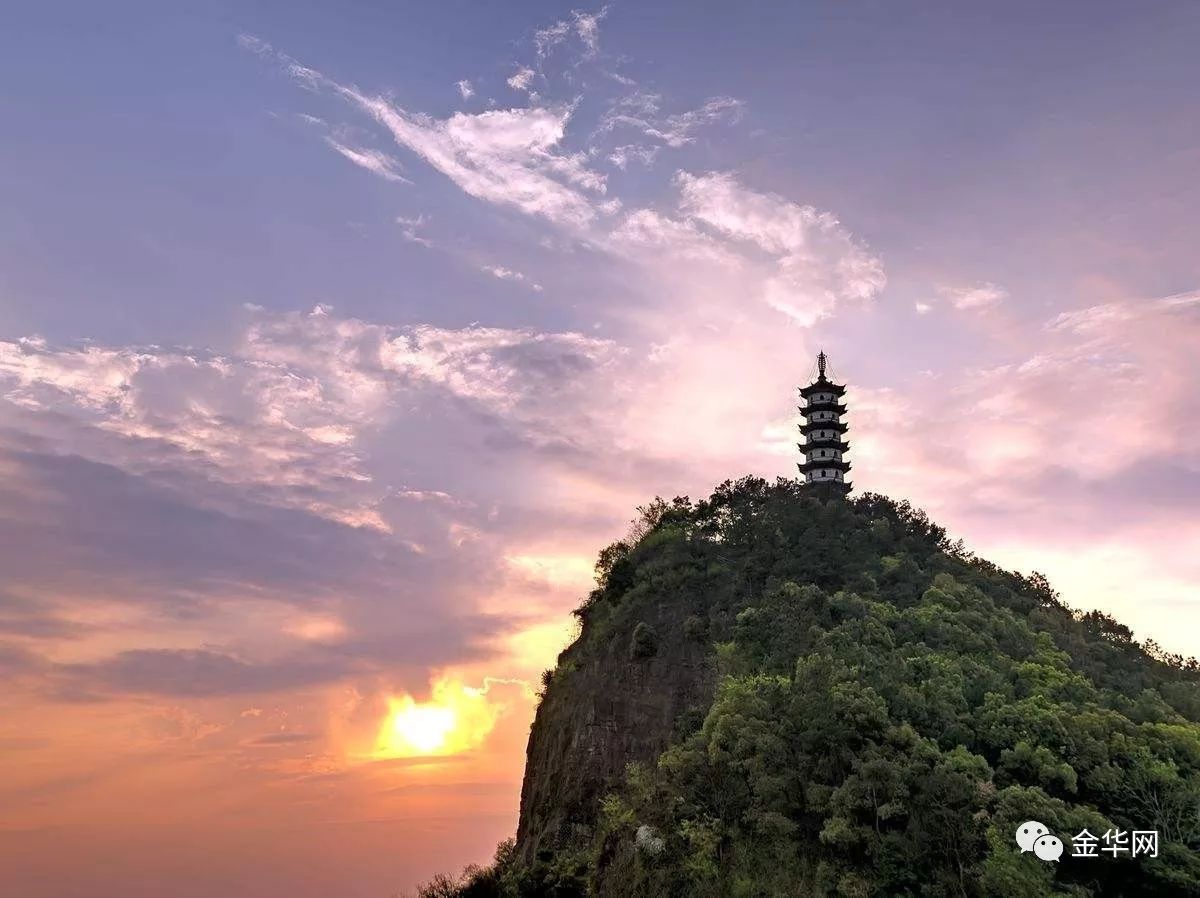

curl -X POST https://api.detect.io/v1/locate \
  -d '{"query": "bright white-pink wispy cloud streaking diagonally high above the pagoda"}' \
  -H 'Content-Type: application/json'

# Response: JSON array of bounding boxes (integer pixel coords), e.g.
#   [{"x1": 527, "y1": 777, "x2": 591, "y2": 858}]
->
[{"x1": 250, "y1": 42, "x2": 884, "y2": 333}]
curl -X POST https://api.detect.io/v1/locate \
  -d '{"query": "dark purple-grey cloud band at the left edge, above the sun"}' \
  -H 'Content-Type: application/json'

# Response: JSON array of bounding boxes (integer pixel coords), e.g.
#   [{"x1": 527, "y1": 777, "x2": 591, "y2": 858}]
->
[{"x1": 0, "y1": 446, "x2": 413, "y2": 607}]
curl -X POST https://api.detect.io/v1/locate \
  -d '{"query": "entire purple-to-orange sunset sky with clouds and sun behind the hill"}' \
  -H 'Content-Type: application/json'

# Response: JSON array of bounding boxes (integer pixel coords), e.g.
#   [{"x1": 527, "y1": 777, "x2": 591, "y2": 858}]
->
[{"x1": 0, "y1": 0, "x2": 1200, "y2": 898}]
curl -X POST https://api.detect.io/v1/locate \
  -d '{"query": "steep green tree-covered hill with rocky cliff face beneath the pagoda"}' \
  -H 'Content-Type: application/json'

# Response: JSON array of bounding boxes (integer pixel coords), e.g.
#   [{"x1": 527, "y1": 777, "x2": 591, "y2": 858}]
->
[{"x1": 421, "y1": 478, "x2": 1200, "y2": 898}]
